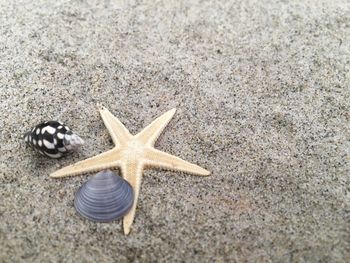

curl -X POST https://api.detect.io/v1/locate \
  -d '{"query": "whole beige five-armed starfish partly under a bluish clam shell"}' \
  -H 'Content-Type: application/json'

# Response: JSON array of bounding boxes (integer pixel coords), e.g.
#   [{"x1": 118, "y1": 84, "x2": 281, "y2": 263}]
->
[{"x1": 50, "y1": 108, "x2": 210, "y2": 235}]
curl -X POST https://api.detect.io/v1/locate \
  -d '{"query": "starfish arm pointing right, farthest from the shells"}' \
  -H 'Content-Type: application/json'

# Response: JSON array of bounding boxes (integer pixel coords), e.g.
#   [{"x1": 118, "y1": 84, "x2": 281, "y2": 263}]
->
[{"x1": 145, "y1": 148, "x2": 210, "y2": 176}]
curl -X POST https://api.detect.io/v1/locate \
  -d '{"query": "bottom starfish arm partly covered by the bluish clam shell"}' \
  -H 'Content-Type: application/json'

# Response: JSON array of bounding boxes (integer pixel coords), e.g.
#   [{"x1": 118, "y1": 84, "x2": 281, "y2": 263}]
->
[{"x1": 121, "y1": 162, "x2": 143, "y2": 235}]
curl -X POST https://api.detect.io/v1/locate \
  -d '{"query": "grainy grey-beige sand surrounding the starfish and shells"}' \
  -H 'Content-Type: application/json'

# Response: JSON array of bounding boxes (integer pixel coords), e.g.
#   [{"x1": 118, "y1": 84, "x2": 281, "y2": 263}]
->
[{"x1": 0, "y1": 0, "x2": 350, "y2": 262}]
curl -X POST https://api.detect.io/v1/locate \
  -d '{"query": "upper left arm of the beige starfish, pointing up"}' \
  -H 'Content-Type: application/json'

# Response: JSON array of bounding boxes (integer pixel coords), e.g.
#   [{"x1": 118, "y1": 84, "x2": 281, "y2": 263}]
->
[{"x1": 100, "y1": 107, "x2": 132, "y2": 146}]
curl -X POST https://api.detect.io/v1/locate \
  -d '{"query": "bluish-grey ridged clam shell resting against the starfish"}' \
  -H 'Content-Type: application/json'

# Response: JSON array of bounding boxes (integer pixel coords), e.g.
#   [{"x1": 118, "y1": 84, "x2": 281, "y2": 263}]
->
[{"x1": 74, "y1": 170, "x2": 134, "y2": 222}]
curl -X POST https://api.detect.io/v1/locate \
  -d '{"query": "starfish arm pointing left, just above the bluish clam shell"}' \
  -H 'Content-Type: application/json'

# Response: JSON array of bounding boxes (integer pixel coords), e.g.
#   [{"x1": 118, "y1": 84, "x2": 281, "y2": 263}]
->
[{"x1": 50, "y1": 149, "x2": 121, "y2": 178}]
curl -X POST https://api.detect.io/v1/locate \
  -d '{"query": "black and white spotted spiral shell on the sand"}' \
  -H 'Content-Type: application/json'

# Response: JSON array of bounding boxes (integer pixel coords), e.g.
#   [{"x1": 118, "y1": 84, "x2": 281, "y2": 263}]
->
[{"x1": 24, "y1": 121, "x2": 84, "y2": 158}]
